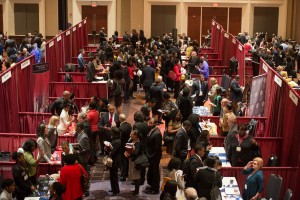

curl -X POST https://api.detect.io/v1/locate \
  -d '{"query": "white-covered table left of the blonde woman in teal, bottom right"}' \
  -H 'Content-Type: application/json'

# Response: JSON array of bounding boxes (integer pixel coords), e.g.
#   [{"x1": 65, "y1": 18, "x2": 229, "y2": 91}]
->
[{"x1": 220, "y1": 177, "x2": 242, "y2": 200}]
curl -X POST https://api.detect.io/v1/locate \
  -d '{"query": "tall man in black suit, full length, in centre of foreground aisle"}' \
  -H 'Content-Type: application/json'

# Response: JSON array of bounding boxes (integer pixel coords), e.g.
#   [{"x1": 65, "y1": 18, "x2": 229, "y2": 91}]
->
[{"x1": 145, "y1": 118, "x2": 162, "y2": 194}]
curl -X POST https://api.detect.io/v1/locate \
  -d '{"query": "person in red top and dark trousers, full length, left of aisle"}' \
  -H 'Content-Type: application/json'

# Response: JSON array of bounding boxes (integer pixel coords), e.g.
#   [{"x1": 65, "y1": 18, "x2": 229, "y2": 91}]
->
[{"x1": 87, "y1": 102, "x2": 100, "y2": 165}]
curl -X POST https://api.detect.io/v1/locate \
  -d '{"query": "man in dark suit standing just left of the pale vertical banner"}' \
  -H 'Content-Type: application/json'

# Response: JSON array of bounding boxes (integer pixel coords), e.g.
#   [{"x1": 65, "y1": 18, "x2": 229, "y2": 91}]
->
[{"x1": 230, "y1": 75, "x2": 243, "y2": 114}]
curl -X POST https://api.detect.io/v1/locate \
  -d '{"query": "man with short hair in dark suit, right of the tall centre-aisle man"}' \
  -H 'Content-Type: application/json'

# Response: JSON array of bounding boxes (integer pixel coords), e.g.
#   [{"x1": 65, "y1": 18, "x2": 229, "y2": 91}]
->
[{"x1": 173, "y1": 120, "x2": 192, "y2": 163}]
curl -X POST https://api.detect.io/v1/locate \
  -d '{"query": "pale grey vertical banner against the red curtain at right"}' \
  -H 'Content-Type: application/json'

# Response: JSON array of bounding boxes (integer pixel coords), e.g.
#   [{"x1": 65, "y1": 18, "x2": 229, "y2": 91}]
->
[{"x1": 249, "y1": 74, "x2": 267, "y2": 117}]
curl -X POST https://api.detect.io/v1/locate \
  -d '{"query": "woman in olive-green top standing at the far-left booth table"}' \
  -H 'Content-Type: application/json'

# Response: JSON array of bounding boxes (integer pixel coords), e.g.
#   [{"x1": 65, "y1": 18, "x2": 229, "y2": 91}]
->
[{"x1": 23, "y1": 139, "x2": 45, "y2": 184}]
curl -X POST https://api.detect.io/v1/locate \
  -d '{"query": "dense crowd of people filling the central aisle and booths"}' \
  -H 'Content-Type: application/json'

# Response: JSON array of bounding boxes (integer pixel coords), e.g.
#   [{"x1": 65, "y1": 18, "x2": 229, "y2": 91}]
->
[{"x1": 1, "y1": 29, "x2": 296, "y2": 200}]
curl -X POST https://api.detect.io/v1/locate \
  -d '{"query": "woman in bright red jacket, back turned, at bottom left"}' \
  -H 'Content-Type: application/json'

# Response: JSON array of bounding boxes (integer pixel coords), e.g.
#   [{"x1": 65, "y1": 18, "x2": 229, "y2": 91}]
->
[{"x1": 58, "y1": 154, "x2": 88, "y2": 200}]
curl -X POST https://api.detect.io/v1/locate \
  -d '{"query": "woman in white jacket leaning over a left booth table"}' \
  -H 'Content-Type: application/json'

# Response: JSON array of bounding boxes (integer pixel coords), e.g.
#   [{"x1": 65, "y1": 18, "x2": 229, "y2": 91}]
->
[{"x1": 57, "y1": 102, "x2": 75, "y2": 135}]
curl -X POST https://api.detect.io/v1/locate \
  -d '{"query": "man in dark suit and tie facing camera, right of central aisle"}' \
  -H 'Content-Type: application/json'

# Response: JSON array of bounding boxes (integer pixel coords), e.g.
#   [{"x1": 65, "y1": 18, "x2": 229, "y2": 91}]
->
[{"x1": 192, "y1": 74, "x2": 208, "y2": 106}]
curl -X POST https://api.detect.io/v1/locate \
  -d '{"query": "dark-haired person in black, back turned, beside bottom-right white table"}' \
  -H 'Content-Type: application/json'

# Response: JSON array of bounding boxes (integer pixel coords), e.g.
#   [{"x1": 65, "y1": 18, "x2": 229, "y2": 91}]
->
[{"x1": 194, "y1": 156, "x2": 222, "y2": 200}]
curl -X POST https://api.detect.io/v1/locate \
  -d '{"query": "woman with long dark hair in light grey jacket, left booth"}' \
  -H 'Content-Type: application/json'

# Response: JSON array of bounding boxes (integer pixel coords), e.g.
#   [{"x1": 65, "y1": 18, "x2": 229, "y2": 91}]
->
[{"x1": 37, "y1": 124, "x2": 51, "y2": 163}]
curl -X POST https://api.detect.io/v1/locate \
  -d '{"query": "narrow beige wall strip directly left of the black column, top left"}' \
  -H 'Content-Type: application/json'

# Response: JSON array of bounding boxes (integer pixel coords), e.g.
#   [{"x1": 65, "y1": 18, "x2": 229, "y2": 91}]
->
[{"x1": 46, "y1": 0, "x2": 58, "y2": 36}]
